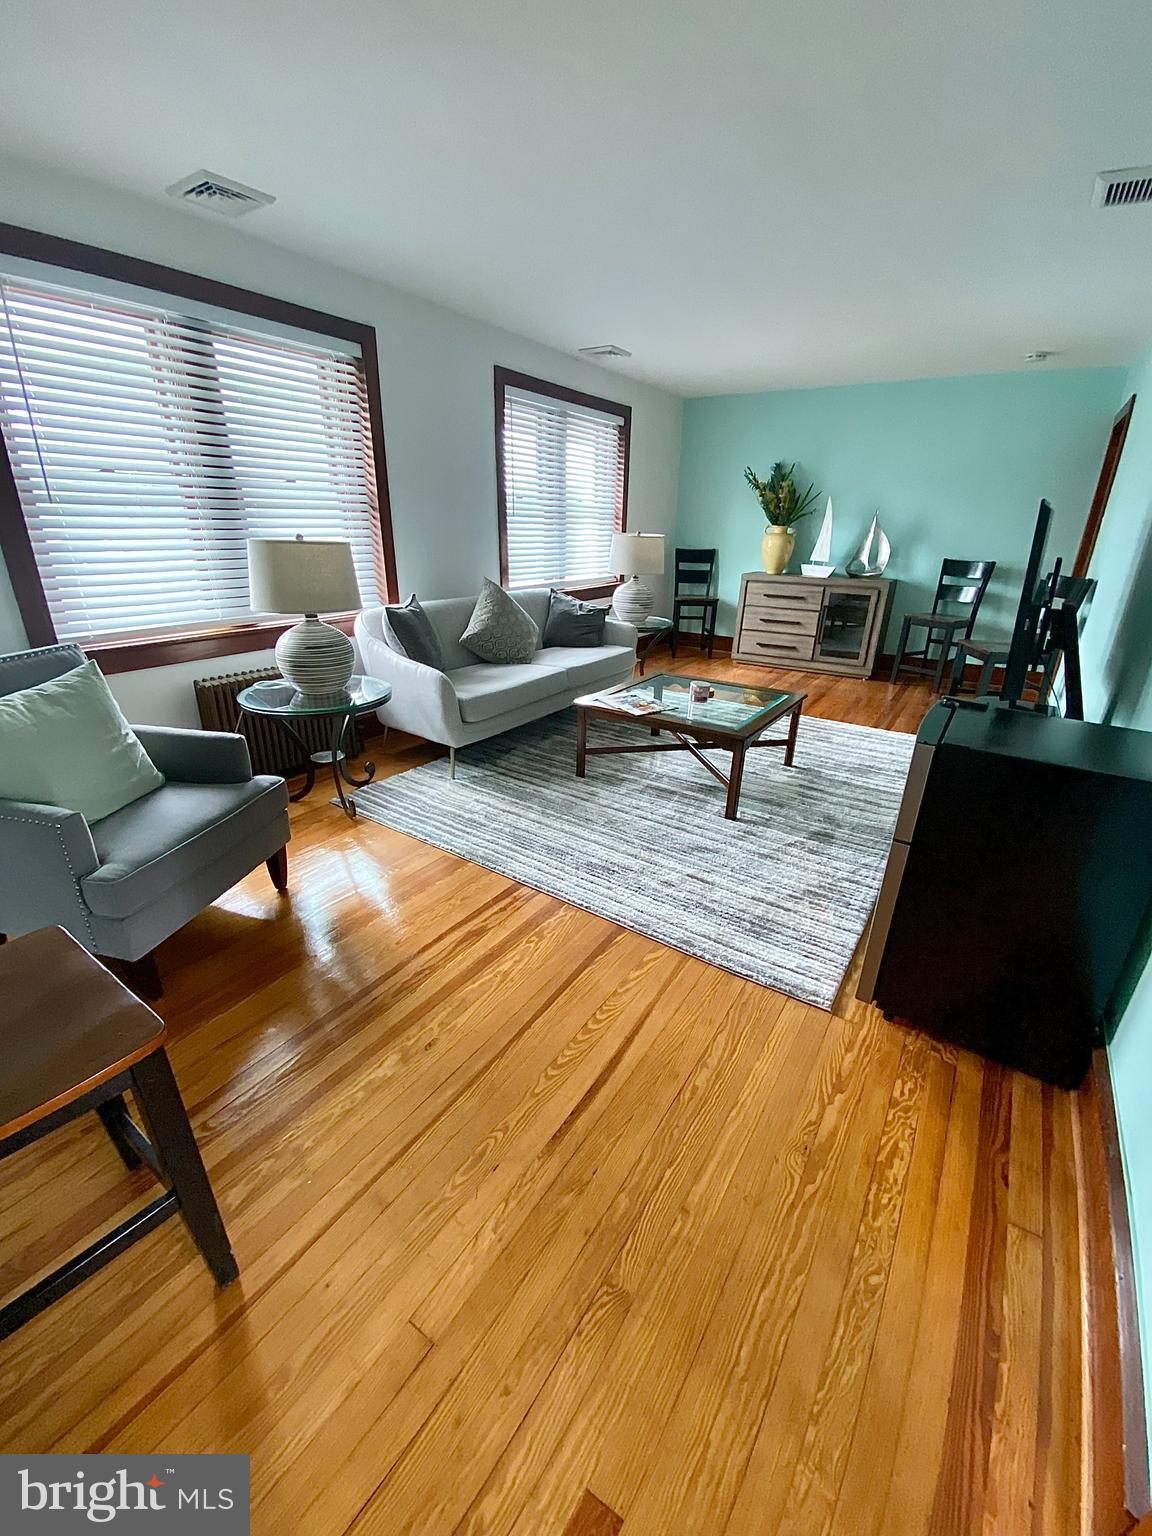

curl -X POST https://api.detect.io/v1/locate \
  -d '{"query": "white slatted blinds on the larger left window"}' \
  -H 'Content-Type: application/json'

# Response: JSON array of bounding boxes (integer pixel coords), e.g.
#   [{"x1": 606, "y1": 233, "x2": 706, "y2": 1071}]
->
[{"x1": 0, "y1": 276, "x2": 384, "y2": 644}]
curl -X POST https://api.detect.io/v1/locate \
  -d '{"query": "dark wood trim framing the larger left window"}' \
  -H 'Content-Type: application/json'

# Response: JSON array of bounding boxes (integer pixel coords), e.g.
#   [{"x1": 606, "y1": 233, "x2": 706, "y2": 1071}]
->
[{"x1": 0, "y1": 223, "x2": 399, "y2": 673}]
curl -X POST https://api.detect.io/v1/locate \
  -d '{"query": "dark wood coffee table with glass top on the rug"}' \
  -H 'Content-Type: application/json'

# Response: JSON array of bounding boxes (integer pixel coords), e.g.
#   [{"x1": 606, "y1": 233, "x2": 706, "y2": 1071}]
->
[{"x1": 576, "y1": 673, "x2": 808, "y2": 822}]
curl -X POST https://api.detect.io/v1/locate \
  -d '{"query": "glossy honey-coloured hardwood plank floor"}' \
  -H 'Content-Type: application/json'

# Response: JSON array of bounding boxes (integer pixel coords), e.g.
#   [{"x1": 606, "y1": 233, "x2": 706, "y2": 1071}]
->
[{"x1": 0, "y1": 654, "x2": 1081, "y2": 1536}]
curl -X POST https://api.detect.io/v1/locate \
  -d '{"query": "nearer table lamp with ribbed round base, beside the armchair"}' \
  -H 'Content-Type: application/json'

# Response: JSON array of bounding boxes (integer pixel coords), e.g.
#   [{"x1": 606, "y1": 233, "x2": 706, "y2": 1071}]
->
[{"x1": 247, "y1": 533, "x2": 359, "y2": 696}]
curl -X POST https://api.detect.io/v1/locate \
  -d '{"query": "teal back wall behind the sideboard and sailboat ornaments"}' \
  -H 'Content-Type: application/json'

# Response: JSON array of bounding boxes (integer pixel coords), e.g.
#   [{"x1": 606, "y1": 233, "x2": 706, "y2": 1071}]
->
[{"x1": 677, "y1": 369, "x2": 1124, "y2": 648}]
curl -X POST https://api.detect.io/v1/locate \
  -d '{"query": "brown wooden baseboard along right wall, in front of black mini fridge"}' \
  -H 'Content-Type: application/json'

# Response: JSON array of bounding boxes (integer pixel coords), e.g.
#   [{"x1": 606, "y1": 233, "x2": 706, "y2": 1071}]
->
[{"x1": 1077, "y1": 1048, "x2": 1152, "y2": 1536}]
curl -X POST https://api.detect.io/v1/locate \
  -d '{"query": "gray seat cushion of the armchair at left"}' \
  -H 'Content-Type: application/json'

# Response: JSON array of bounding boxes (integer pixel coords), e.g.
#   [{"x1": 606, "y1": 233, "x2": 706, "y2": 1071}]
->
[{"x1": 80, "y1": 774, "x2": 287, "y2": 917}]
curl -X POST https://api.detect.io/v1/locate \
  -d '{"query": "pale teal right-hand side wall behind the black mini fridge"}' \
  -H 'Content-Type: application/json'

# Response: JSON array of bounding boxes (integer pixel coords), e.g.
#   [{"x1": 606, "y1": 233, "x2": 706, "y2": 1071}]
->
[{"x1": 1083, "y1": 347, "x2": 1152, "y2": 1486}]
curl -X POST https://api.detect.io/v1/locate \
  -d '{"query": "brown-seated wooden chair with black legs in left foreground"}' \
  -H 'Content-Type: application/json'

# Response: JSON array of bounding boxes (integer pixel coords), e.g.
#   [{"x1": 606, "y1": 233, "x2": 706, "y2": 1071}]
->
[{"x1": 0, "y1": 928, "x2": 238, "y2": 1338}]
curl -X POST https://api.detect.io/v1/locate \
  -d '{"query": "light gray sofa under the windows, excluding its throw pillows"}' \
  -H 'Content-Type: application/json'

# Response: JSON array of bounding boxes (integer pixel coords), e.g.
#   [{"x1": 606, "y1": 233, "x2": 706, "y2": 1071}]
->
[{"x1": 356, "y1": 587, "x2": 636, "y2": 766}]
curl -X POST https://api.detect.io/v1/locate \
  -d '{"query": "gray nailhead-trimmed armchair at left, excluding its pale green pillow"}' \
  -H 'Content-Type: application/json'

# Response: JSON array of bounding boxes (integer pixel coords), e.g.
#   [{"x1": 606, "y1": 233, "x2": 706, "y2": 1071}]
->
[{"x1": 0, "y1": 645, "x2": 292, "y2": 995}]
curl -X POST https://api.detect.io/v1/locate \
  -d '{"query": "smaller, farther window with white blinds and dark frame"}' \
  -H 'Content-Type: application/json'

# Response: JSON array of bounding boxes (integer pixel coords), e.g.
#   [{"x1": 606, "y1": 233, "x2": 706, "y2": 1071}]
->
[{"x1": 496, "y1": 369, "x2": 631, "y2": 590}]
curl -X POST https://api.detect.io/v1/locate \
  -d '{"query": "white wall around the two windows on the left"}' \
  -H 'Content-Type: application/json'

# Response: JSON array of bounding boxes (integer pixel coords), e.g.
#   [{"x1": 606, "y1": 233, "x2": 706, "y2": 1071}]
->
[{"x1": 0, "y1": 157, "x2": 680, "y2": 723}]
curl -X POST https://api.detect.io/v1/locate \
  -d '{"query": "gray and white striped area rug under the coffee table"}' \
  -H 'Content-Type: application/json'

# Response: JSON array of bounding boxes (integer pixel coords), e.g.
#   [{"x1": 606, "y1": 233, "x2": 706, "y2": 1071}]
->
[{"x1": 353, "y1": 711, "x2": 914, "y2": 1008}]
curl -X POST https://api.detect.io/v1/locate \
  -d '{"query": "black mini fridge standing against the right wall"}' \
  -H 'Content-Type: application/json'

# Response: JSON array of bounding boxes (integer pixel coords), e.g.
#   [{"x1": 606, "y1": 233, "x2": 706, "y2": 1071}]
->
[{"x1": 859, "y1": 703, "x2": 1152, "y2": 1087}]
